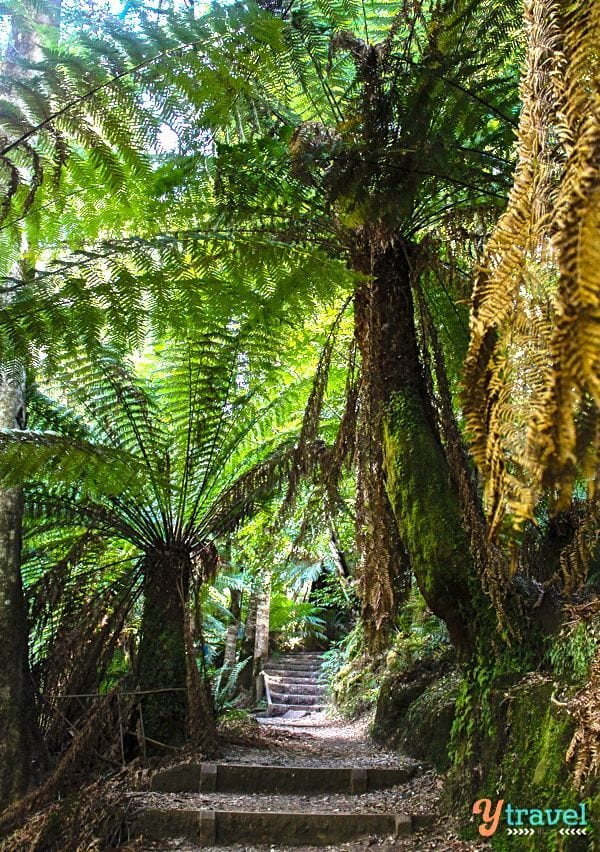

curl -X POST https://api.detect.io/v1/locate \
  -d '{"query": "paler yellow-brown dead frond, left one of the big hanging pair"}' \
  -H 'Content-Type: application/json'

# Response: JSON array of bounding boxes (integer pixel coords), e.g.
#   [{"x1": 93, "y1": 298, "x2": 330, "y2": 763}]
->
[{"x1": 465, "y1": 0, "x2": 561, "y2": 535}]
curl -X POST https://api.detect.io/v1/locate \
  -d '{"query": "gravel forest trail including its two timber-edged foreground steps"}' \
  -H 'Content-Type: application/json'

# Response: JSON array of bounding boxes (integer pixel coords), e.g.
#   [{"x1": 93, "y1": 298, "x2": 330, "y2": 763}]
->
[{"x1": 131, "y1": 652, "x2": 485, "y2": 852}]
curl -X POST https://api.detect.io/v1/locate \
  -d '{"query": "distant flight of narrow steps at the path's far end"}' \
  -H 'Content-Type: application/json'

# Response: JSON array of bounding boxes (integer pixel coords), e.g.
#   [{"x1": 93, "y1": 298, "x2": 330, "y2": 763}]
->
[{"x1": 263, "y1": 652, "x2": 326, "y2": 718}]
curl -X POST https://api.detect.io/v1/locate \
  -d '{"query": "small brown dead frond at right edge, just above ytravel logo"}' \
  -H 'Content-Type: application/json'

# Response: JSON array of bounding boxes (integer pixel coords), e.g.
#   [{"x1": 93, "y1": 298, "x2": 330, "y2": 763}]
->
[{"x1": 561, "y1": 652, "x2": 600, "y2": 790}]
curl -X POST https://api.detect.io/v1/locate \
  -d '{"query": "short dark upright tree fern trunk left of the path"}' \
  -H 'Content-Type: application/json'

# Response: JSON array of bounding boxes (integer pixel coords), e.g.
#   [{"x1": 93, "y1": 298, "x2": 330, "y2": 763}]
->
[{"x1": 138, "y1": 551, "x2": 190, "y2": 746}]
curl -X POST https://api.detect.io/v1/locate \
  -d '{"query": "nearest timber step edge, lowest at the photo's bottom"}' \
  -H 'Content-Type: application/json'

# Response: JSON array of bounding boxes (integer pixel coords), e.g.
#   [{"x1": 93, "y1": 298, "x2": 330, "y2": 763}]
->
[{"x1": 136, "y1": 808, "x2": 435, "y2": 847}]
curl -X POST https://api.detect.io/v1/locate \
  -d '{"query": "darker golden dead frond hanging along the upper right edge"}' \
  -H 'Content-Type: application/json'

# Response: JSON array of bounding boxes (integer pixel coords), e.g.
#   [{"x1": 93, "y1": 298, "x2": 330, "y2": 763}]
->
[{"x1": 529, "y1": 0, "x2": 600, "y2": 507}]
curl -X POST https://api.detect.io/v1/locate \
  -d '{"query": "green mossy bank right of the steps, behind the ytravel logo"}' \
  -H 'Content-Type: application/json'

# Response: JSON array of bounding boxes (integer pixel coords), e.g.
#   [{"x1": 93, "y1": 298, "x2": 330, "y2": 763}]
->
[{"x1": 450, "y1": 675, "x2": 600, "y2": 852}]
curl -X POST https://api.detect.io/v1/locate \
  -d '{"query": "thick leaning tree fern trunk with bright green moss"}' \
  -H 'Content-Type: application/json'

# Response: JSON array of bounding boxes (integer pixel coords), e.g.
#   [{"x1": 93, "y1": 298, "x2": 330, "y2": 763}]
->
[{"x1": 354, "y1": 238, "x2": 487, "y2": 654}]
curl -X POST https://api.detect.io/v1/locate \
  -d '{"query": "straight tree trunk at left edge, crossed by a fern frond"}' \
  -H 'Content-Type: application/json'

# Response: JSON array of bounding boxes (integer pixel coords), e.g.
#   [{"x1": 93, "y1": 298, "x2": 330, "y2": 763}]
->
[{"x1": 0, "y1": 367, "x2": 44, "y2": 806}]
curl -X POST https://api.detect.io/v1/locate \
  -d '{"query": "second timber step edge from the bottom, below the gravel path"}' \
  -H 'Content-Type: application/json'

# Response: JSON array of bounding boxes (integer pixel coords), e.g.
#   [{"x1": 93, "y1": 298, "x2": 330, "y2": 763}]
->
[{"x1": 151, "y1": 763, "x2": 416, "y2": 795}]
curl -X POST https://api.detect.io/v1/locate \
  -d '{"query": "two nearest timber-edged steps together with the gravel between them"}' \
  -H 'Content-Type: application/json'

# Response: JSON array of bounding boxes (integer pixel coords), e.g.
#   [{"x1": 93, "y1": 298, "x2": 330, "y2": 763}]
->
[{"x1": 135, "y1": 763, "x2": 435, "y2": 850}]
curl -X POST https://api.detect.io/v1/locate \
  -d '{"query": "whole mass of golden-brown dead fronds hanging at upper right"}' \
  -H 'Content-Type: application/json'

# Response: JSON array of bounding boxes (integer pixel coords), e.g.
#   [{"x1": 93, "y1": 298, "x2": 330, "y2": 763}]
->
[{"x1": 465, "y1": 0, "x2": 600, "y2": 535}]
